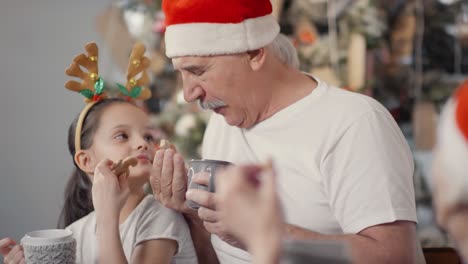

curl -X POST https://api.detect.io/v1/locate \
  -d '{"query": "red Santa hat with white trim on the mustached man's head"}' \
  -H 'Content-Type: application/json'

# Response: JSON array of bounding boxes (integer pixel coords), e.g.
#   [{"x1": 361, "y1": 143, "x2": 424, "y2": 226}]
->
[{"x1": 162, "y1": 0, "x2": 279, "y2": 58}]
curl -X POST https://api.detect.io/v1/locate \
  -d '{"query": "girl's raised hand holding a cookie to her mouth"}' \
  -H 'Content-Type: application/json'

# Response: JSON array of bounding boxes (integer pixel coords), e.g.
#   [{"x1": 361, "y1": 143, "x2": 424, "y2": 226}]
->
[{"x1": 92, "y1": 159, "x2": 130, "y2": 223}]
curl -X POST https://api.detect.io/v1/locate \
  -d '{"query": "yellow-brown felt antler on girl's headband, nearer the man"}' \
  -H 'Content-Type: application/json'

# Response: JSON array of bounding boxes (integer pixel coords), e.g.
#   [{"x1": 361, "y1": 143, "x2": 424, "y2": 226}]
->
[{"x1": 125, "y1": 43, "x2": 151, "y2": 100}]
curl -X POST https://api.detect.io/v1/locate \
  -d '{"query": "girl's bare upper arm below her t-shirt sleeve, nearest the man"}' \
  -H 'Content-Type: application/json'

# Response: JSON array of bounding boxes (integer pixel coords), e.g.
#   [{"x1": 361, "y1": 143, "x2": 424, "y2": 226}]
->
[{"x1": 132, "y1": 239, "x2": 177, "y2": 264}]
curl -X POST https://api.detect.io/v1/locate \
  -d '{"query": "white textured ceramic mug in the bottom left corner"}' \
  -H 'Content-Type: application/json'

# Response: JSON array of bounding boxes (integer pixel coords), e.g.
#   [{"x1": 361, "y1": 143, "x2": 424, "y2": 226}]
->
[{"x1": 21, "y1": 229, "x2": 76, "y2": 264}]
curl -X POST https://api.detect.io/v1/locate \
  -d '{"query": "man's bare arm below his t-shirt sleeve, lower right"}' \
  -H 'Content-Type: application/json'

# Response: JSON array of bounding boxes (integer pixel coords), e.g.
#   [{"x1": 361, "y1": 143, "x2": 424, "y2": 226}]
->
[{"x1": 285, "y1": 221, "x2": 417, "y2": 264}]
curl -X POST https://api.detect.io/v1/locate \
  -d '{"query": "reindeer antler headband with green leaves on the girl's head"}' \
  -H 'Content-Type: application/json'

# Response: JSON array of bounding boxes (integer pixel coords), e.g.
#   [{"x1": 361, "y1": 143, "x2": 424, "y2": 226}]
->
[{"x1": 65, "y1": 42, "x2": 151, "y2": 152}]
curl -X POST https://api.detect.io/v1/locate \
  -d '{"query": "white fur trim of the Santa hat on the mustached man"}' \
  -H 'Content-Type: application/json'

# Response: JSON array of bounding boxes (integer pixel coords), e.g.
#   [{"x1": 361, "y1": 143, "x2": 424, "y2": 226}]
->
[{"x1": 165, "y1": 15, "x2": 280, "y2": 58}]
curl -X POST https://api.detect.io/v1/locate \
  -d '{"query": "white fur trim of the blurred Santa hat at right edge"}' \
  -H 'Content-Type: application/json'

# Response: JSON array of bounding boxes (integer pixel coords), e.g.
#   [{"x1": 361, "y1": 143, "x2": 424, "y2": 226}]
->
[{"x1": 436, "y1": 99, "x2": 468, "y2": 205}]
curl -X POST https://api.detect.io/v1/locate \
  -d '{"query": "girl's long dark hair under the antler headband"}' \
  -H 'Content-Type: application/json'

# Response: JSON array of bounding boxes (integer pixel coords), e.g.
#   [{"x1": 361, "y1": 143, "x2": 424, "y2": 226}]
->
[{"x1": 58, "y1": 98, "x2": 129, "y2": 228}]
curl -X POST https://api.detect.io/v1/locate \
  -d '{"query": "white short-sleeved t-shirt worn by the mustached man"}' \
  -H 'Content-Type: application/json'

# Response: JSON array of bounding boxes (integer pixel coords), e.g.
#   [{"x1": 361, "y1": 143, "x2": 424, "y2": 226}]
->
[{"x1": 202, "y1": 75, "x2": 417, "y2": 263}]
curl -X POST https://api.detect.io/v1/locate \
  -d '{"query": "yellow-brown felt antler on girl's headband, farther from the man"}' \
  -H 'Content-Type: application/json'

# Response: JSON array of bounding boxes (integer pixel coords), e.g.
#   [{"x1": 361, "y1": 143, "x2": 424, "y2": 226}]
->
[{"x1": 65, "y1": 42, "x2": 99, "y2": 93}]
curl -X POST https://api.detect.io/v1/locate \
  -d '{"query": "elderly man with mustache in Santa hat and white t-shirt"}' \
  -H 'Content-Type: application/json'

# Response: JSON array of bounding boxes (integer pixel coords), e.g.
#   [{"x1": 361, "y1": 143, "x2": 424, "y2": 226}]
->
[{"x1": 151, "y1": 0, "x2": 420, "y2": 263}]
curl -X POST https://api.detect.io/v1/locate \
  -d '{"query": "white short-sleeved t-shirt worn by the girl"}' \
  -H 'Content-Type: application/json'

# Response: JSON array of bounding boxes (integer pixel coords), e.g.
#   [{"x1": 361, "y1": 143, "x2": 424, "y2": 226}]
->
[{"x1": 66, "y1": 195, "x2": 198, "y2": 264}]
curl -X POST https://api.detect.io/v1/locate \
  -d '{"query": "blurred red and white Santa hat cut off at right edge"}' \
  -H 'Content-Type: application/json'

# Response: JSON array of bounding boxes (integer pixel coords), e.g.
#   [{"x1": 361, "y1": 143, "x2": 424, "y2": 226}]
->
[{"x1": 436, "y1": 81, "x2": 468, "y2": 204}]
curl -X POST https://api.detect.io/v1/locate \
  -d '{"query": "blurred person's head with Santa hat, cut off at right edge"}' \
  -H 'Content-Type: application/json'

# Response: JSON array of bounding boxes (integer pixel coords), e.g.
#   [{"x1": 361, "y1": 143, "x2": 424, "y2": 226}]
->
[{"x1": 432, "y1": 81, "x2": 468, "y2": 261}]
